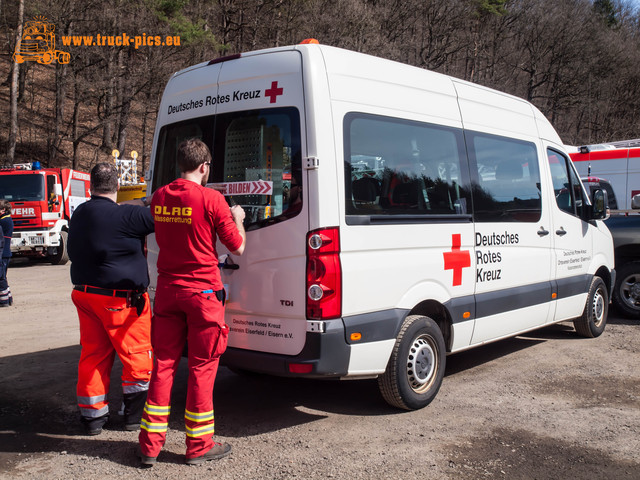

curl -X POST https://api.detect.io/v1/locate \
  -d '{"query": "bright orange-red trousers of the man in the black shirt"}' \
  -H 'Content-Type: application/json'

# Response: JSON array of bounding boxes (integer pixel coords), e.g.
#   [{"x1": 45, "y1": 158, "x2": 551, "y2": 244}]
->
[{"x1": 71, "y1": 290, "x2": 153, "y2": 419}]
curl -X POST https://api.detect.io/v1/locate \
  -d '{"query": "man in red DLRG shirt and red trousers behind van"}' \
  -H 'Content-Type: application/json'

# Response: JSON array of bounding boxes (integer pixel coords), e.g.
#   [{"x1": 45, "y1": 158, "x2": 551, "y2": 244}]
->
[{"x1": 139, "y1": 139, "x2": 246, "y2": 466}]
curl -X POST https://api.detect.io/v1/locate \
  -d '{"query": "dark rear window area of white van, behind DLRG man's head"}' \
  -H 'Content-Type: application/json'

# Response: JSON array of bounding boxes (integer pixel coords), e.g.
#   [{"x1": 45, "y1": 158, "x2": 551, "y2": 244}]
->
[{"x1": 153, "y1": 107, "x2": 302, "y2": 230}]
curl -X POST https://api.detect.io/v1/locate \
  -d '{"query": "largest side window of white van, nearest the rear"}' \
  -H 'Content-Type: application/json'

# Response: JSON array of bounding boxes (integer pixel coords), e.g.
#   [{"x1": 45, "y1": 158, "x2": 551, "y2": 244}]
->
[{"x1": 344, "y1": 113, "x2": 471, "y2": 216}]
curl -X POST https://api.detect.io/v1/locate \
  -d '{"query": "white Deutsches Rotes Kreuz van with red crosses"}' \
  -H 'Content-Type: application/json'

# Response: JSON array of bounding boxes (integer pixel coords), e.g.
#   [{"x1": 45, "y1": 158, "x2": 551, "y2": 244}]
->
[{"x1": 148, "y1": 44, "x2": 614, "y2": 409}]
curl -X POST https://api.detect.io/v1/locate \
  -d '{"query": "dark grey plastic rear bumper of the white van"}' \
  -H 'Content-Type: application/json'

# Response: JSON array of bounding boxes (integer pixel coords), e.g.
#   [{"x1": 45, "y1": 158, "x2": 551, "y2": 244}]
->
[{"x1": 221, "y1": 318, "x2": 350, "y2": 378}]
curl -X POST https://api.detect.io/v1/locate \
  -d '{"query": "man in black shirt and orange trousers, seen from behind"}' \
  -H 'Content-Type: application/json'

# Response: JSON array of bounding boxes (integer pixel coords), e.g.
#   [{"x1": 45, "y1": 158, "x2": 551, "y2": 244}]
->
[{"x1": 68, "y1": 163, "x2": 153, "y2": 435}]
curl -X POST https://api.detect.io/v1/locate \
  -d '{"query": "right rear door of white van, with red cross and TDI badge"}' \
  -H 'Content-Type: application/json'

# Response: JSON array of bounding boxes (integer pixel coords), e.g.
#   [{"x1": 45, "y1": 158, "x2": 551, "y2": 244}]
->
[{"x1": 210, "y1": 50, "x2": 309, "y2": 355}]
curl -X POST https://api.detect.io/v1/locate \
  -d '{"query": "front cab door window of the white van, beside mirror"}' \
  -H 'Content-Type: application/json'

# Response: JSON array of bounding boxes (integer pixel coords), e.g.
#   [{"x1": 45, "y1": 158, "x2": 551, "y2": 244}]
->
[{"x1": 547, "y1": 149, "x2": 587, "y2": 217}]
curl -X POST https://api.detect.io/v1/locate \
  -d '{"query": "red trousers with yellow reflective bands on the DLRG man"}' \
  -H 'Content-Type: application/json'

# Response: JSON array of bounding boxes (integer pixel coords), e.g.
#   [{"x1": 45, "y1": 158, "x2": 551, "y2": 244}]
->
[{"x1": 139, "y1": 285, "x2": 229, "y2": 458}]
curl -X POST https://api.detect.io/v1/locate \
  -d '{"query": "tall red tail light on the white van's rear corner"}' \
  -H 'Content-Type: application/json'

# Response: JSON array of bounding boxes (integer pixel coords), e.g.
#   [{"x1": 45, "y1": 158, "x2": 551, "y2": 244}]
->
[{"x1": 306, "y1": 227, "x2": 342, "y2": 320}]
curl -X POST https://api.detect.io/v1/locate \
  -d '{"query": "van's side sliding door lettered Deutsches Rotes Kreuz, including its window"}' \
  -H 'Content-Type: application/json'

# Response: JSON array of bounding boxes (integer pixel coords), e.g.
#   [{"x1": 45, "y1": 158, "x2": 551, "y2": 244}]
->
[{"x1": 465, "y1": 131, "x2": 551, "y2": 344}]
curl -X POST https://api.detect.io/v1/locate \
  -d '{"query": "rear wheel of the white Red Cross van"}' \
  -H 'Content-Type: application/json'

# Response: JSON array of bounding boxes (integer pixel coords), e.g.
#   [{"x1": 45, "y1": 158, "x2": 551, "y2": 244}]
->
[{"x1": 378, "y1": 315, "x2": 446, "y2": 410}]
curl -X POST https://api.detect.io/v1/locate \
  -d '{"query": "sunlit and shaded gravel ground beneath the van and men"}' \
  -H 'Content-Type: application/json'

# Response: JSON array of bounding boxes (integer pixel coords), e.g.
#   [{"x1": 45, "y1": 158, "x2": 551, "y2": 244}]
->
[{"x1": 0, "y1": 262, "x2": 640, "y2": 480}]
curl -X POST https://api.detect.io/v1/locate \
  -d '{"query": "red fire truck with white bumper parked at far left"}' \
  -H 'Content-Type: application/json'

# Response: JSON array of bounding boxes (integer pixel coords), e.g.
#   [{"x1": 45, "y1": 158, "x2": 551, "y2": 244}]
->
[{"x1": 0, "y1": 162, "x2": 90, "y2": 265}]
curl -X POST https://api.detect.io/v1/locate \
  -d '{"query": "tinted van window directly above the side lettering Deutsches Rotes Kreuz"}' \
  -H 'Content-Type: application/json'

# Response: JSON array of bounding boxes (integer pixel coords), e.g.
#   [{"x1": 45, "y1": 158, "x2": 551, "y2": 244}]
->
[{"x1": 465, "y1": 132, "x2": 542, "y2": 222}]
